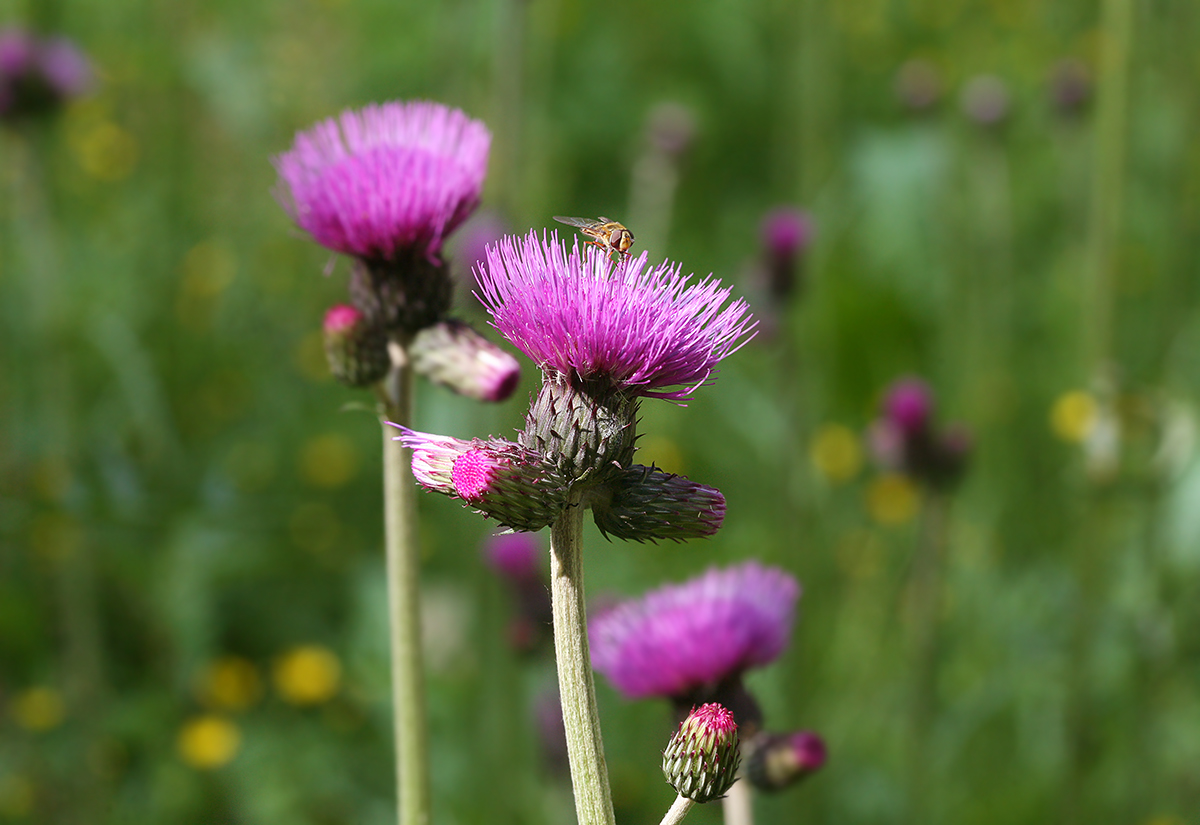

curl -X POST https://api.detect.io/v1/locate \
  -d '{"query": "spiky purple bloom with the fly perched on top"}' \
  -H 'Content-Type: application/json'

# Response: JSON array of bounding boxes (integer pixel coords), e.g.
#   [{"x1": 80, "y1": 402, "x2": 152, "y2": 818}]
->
[{"x1": 476, "y1": 233, "x2": 755, "y2": 401}]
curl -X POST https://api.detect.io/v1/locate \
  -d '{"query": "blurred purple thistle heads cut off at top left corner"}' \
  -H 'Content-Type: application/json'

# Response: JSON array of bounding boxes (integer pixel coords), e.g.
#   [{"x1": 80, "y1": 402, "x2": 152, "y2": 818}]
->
[{"x1": 0, "y1": 28, "x2": 95, "y2": 120}]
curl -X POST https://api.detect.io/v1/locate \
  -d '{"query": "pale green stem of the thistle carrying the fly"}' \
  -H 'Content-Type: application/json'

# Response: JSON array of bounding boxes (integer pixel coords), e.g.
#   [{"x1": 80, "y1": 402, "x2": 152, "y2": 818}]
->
[{"x1": 550, "y1": 500, "x2": 616, "y2": 825}]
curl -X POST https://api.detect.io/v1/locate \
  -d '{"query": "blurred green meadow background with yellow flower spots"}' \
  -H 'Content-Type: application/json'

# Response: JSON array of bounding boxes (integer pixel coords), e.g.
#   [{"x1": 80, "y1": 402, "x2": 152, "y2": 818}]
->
[{"x1": 0, "y1": 0, "x2": 1200, "y2": 825}]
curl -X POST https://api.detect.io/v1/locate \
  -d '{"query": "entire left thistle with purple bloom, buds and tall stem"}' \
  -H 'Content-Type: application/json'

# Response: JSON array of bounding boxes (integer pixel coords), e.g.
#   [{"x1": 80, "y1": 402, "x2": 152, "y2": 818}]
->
[{"x1": 275, "y1": 102, "x2": 506, "y2": 825}]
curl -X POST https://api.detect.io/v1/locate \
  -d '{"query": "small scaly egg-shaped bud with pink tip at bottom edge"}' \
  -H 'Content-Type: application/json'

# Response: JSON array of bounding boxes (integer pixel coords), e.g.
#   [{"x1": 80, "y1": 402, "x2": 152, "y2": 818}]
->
[{"x1": 662, "y1": 703, "x2": 742, "y2": 802}]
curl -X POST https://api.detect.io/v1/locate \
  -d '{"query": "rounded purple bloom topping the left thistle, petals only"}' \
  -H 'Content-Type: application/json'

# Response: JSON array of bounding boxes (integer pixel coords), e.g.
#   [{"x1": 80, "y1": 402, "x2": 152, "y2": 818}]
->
[{"x1": 275, "y1": 101, "x2": 491, "y2": 260}]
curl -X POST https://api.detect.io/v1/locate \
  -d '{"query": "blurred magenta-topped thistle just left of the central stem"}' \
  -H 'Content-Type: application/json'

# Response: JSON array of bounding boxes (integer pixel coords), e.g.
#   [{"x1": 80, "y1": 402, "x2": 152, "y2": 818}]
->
[{"x1": 484, "y1": 532, "x2": 553, "y2": 652}]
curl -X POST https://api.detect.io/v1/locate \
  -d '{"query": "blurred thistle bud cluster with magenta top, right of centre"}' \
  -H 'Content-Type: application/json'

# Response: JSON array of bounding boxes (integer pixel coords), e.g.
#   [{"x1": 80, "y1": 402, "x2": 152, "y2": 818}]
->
[{"x1": 868, "y1": 378, "x2": 972, "y2": 489}]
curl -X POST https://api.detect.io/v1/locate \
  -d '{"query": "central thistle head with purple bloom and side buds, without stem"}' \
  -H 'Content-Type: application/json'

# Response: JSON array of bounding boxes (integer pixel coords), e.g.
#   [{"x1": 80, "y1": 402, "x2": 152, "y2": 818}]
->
[{"x1": 400, "y1": 233, "x2": 754, "y2": 541}]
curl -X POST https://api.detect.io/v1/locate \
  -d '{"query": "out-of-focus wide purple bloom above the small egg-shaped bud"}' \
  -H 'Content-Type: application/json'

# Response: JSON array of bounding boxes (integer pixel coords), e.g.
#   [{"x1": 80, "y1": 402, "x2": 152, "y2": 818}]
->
[{"x1": 589, "y1": 561, "x2": 800, "y2": 699}]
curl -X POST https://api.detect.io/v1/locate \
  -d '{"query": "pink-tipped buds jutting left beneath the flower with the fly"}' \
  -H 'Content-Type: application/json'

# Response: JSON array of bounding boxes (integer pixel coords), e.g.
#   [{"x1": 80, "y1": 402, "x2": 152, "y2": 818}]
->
[{"x1": 397, "y1": 427, "x2": 566, "y2": 531}]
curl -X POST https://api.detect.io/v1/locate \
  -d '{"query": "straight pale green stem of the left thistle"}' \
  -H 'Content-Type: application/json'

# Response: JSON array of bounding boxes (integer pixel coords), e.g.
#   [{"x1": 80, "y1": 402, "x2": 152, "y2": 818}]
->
[{"x1": 382, "y1": 354, "x2": 430, "y2": 825}]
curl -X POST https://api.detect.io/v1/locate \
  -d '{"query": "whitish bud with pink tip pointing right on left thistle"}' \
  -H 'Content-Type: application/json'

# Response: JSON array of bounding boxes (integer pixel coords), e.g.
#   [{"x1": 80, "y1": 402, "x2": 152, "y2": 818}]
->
[{"x1": 409, "y1": 319, "x2": 521, "y2": 401}]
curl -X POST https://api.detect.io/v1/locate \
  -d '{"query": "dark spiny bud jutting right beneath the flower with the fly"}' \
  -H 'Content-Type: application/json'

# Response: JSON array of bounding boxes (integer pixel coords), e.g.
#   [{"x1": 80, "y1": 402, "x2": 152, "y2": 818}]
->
[{"x1": 592, "y1": 464, "x2": 725, "y2": 541}]
